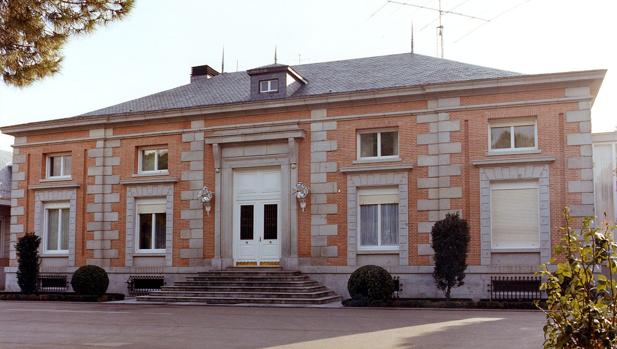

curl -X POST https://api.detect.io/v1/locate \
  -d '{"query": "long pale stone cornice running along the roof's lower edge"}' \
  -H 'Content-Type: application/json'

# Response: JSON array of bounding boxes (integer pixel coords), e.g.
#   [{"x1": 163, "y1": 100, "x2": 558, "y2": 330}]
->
[{"x1": 0, "y1": 69, "x2": 606, "y2": 135}]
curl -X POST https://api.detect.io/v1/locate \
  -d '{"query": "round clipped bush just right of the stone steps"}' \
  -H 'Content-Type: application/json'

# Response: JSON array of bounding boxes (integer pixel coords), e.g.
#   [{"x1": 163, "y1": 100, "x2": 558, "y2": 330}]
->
[{"x1": 347, "y1": 265, "x2": 394, "y2": 303}]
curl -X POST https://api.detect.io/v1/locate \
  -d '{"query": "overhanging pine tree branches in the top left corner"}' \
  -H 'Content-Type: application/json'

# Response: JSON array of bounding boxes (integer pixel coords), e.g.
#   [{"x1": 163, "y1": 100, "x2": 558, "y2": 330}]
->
[{"x1": 0, "y1": 0, "x2": 134, "y2": 87}]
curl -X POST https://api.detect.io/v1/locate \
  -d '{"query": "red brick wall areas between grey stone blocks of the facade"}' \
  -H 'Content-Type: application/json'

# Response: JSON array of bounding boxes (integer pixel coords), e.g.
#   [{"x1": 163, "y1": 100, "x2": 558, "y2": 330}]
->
[{"x1": 6, "y1": 83, "x2": 592, "y2": 267}]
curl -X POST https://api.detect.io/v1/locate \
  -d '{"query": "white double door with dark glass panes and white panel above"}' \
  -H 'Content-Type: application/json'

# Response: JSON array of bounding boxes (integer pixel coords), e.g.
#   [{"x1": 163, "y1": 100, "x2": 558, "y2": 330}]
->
[{"x1": 233, "y1": 168, "x2": 281, "y2": 265}]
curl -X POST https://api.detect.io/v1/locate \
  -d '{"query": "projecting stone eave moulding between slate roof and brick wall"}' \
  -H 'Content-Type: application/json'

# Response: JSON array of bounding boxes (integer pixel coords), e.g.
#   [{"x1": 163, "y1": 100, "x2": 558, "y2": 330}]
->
[{"x1": 0, "y1": 70, "x2": 606, "y2": 135}]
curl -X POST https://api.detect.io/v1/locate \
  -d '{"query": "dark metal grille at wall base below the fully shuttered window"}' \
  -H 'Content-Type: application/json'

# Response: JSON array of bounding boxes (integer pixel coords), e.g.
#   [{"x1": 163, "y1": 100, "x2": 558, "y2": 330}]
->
[{"x1": 488, "y1": 276, "x2": 544, "y2": 301}]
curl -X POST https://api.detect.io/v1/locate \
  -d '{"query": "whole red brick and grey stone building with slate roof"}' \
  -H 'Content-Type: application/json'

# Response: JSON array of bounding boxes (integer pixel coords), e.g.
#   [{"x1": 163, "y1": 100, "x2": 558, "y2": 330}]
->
[{"x1": 2, "y1": 53, "x2": 605, "y2": 298}]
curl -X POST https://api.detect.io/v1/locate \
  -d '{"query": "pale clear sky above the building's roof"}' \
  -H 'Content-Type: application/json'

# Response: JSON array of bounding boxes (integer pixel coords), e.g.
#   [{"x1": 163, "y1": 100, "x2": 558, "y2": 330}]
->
[{"x1": 0, "y1": 0, "x2": 617, "y2": 150}]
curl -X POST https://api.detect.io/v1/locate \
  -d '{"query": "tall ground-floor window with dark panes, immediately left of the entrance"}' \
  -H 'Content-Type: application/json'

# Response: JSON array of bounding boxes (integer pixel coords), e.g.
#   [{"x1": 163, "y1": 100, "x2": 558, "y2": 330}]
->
[{"x1": 135, "y1": 198, "x2": 167, "y2": 253}]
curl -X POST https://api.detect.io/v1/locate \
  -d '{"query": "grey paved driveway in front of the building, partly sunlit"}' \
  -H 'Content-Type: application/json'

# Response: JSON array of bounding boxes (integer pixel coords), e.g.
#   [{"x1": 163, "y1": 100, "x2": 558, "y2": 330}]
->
[{"x1": 0, "y1": 301, "x2": 544, "y2": 349}]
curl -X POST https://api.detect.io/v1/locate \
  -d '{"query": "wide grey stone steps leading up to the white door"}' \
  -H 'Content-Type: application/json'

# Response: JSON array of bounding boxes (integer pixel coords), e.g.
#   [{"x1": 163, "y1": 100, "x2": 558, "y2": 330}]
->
[{"x1": 137, "y1": 268, "x2": 341, "y2": 305}]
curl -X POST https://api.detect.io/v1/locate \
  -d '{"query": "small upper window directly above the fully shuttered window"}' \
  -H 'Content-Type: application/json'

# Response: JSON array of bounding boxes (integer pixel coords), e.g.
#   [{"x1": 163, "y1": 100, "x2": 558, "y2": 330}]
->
[{"x1": 488, "y1": 118, "x2": 538, "y2": 152}]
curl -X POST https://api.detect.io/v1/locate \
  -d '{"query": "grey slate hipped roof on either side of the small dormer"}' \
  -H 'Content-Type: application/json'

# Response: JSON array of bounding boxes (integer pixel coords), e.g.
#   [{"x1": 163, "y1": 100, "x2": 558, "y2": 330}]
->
[{"x1": 82, "y1": 53, "x2": 520, "y2": 116}]
